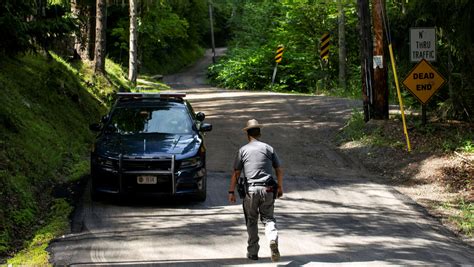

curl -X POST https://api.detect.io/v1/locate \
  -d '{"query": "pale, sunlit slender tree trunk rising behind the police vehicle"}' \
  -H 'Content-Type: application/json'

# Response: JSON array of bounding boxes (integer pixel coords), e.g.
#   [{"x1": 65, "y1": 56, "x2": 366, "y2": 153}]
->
[{"x1": 128, "y1": 0, "x2": 138, "y2": 86}]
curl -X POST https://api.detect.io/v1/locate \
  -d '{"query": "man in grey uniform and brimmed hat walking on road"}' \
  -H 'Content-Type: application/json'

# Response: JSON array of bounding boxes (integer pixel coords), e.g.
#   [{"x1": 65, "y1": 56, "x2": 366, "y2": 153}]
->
[{"x1": 228, "y1": 119, "x2": 283, "y2": 262}]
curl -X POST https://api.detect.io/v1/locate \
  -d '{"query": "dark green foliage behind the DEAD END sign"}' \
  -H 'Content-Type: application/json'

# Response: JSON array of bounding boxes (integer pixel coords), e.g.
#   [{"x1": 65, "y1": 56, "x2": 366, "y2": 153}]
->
[{"x1": 388, "y1": 0, "x2": 474, "y2": 121}]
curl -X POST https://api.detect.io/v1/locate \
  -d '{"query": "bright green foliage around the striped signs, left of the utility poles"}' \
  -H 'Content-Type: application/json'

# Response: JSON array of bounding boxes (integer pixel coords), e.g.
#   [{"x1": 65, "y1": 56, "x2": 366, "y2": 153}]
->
[{"x1": 209, "y1": 0, "x2": 360, "y2": 95}]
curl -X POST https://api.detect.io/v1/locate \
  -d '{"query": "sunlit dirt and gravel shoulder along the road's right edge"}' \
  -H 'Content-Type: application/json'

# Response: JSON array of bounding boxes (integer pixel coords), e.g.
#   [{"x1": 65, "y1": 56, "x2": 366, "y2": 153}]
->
[{"x1": 340, "y1": 120, "x2": 474, "y2": 246}]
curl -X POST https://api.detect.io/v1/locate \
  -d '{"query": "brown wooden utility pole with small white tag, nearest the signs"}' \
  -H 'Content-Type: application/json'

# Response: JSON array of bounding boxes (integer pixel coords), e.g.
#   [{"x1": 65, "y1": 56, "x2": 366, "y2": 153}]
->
[{"x1": 372, "y1": 0, "x2": 388, "y2": 120}]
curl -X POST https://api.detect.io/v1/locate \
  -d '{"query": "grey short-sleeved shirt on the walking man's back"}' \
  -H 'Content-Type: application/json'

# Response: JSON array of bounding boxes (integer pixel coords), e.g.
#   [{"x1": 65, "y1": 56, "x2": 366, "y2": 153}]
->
[{"x1": 234, "y1": 140, "x2": 280, "y2": 183}]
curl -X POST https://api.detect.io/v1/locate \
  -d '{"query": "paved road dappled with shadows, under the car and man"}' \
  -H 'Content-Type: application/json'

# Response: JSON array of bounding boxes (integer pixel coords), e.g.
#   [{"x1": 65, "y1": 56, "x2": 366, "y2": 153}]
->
[{"x1": 49, "y1": 51, "x2": 474, "y2": 266}]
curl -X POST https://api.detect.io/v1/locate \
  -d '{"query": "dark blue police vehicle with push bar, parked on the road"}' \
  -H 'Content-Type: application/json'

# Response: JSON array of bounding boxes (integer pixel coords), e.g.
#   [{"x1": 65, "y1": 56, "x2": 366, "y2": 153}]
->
[{"x1": 90, "y1": 93, "x2": 212, "y2": 201}]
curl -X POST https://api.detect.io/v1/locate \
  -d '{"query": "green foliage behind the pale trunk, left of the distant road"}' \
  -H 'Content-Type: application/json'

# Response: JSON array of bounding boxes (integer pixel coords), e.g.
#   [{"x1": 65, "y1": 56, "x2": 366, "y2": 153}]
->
[{"x1": 107, "y1": 0, "x2": 209, "y2": 74}]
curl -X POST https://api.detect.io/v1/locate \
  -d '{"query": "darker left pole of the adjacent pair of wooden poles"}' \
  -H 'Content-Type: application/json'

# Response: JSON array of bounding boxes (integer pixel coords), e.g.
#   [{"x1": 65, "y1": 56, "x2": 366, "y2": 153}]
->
[{"x1": 357, "y1": 0, "x2": 374, "y2": 122}]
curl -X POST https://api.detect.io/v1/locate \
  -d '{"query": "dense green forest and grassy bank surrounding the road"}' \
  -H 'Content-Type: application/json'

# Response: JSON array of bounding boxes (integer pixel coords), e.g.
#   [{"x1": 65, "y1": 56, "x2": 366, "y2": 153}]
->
[{"x1": 0, "y1": 0, "x2": 474, "y2": 264}]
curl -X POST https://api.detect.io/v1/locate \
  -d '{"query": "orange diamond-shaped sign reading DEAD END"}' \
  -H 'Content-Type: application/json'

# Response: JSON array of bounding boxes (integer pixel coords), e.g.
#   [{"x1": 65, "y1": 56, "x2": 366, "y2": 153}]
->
[{"x1": 403, "y1": 59, "x2": 446, "y2": 104}]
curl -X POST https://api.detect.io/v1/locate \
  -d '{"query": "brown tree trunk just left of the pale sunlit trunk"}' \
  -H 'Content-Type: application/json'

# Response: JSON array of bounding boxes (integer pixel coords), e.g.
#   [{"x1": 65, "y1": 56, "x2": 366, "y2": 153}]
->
[{"x1": 94, "y1": 0, "x2": 107, "y2": 74}]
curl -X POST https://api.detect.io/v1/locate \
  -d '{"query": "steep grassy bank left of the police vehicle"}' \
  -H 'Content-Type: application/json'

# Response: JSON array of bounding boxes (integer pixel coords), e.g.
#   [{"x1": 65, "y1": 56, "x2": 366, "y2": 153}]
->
[{"x1": 0, "y1": 54, "x2": 128, "y2": 265}]
